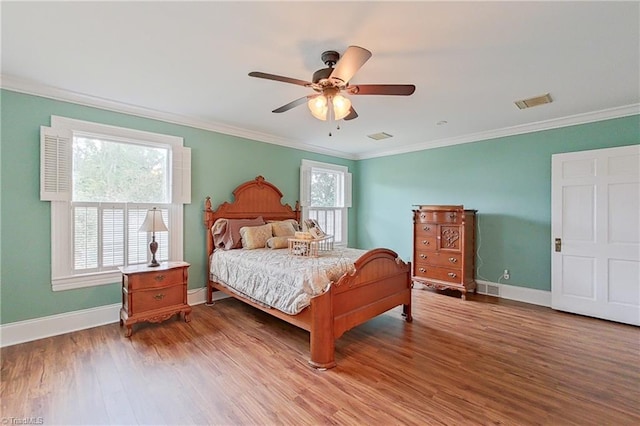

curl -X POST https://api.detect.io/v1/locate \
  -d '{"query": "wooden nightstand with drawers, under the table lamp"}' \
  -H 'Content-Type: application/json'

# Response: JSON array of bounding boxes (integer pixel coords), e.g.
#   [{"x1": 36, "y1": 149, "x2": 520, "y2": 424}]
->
[{"x1": 120, "y1": 262, "x2": 191, "y2": 337}]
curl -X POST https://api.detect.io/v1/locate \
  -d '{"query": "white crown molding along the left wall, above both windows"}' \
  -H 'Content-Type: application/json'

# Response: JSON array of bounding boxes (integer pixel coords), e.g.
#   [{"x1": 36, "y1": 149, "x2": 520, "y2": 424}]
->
[{"x1": 0, "y1": 75, "x2": 356, "y2": 160}]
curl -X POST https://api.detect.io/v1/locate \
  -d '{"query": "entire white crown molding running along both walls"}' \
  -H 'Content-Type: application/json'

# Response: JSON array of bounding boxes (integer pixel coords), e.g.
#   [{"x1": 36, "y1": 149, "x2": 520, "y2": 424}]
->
[{"x1": 0, "y1": 75, "x2": 640, "y2": 160}]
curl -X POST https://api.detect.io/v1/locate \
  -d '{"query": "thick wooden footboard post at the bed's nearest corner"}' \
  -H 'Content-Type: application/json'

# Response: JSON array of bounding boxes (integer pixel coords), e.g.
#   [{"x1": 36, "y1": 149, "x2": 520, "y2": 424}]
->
[{"x1": 309, "y1": 287, "x2": 336, "y2": 369}]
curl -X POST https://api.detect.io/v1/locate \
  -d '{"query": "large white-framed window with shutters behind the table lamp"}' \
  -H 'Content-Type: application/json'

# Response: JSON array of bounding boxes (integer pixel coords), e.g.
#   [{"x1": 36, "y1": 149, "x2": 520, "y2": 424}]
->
[{"x1": 41, "y1": 117, "x2": 190, "y2": 290}]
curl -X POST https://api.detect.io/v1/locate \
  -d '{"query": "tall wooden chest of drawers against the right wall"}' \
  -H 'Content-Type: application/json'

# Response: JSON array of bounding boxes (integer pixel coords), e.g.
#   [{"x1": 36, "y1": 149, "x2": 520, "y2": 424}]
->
[{"x1": 413, "y1": 205, "x2": 476, "y2": 299}]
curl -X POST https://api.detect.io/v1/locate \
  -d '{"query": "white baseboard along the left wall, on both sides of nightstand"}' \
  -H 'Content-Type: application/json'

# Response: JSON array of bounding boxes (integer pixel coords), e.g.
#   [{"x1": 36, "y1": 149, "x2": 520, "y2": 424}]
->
[{"x1": 0, "y1": 287, "x2": 229, "y2": 347}]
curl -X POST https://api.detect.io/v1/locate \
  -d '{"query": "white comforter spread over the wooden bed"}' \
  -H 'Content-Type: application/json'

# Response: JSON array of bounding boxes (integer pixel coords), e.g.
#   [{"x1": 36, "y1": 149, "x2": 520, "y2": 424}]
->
[{"x1": 210, "y1": 248, "x2": 365, "y2": 315}]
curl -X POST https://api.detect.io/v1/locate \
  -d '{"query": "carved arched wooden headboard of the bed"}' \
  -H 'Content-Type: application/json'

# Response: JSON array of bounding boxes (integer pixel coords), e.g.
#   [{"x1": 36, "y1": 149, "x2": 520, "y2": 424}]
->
[{"x1": 204, "y1": 176, "x2": 300, "y2": 256}]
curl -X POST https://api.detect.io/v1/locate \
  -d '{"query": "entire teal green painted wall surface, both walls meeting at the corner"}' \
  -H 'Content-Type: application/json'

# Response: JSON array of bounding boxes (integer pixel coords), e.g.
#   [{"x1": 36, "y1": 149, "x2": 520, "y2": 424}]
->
[{"x1": 0, "y1": 90, "x2": 640, "y2": 324}]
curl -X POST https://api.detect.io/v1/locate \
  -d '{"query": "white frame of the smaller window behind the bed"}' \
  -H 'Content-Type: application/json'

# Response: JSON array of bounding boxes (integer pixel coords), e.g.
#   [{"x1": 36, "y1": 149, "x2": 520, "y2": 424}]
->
[{"x1": 300, "y1": 159, "x2": 352, "y2": 247}]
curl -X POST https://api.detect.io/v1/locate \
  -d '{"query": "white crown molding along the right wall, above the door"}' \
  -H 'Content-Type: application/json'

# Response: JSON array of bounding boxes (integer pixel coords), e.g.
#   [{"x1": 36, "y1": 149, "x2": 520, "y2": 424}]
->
[{"x1": 356, "y1": 104, "x2": 640, "y2": 160}]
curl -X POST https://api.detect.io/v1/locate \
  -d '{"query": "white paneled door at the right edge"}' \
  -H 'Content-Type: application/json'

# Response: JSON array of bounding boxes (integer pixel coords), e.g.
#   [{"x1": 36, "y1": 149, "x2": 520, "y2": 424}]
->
[{"x1": 551, "y1": 145, "x2": 640, "y2": 325}]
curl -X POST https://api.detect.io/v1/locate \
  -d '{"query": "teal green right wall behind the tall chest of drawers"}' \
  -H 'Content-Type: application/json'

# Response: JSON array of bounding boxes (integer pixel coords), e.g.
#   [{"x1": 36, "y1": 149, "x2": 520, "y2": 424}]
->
[{"x1": 354, "y1": 116, "x2": 640, "y2": 290}]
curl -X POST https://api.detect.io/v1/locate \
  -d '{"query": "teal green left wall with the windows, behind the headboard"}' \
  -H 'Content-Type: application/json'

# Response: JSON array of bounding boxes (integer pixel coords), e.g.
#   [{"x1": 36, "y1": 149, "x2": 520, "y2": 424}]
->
[{"x1": 0, "y1": 90, "x2": 357, "y2": 324}]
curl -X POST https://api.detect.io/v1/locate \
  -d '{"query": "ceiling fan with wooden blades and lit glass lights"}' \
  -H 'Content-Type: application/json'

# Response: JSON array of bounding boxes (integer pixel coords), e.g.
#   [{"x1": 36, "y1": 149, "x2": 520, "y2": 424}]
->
[{"x1": 249, "y1": 46, "x2": 416, "y2": 120}]
